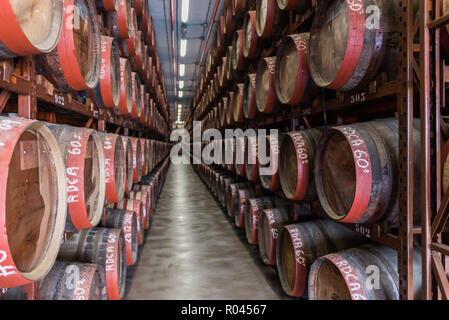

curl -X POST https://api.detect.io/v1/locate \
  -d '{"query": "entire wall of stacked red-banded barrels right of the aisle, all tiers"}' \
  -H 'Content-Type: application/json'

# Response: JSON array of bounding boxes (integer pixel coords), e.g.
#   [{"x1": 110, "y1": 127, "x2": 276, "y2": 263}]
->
[{"x1": 184, "y1": 0, "x2": 421, "y2": 299}]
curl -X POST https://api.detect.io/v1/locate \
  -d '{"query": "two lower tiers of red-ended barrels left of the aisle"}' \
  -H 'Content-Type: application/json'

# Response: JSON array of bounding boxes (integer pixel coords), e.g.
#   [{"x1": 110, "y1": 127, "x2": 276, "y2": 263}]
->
[{"x1": 0, "y1": 117, "x2": 169, "y2": 300}]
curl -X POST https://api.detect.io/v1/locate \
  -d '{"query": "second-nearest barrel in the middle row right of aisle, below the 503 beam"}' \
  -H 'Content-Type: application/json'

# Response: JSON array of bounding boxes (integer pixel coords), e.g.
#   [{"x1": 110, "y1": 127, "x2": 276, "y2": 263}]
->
[{"x1": 279, "y1": 129, "x2": 323, "y2": 201}]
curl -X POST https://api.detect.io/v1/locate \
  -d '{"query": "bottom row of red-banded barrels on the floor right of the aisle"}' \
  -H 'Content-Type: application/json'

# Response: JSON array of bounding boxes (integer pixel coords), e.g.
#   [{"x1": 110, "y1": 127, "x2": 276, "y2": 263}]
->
[{"x1": 191, "y1": 155, "x2": 421, "y2": 300}]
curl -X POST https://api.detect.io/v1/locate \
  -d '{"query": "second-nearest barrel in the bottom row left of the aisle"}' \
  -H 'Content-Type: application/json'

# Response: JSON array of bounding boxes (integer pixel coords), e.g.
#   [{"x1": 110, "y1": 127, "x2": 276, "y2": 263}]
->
[{"x1": 58, "y1": 228, "x2": 126, "y2": 300}]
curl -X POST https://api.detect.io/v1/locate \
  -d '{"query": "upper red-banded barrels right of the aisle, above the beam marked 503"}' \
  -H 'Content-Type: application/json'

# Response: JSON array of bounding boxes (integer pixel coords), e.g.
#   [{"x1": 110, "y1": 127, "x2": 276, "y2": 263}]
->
[{"x1": 193, "y1": 0, "x2": 406, "y2": 129}]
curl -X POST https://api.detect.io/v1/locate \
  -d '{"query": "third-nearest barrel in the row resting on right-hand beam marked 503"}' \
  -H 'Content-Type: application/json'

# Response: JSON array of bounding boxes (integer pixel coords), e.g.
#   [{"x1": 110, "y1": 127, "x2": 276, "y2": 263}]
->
[{"x1": 256, "y1": 57, "x2": 279, "y2": 113}]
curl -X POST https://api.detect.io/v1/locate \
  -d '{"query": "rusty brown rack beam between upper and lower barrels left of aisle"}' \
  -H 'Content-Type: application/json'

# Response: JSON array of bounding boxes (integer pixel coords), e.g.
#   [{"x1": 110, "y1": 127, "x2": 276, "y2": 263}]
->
[{"x1": 0, "y1": 56, "x2": 170, "y2": 140}]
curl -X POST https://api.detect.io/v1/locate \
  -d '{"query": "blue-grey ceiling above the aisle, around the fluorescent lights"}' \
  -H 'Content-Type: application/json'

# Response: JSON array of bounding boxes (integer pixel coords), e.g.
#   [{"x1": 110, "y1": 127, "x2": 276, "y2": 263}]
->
[{"x1": 149, "y1": 0, "x2": 226, "y2": 124}]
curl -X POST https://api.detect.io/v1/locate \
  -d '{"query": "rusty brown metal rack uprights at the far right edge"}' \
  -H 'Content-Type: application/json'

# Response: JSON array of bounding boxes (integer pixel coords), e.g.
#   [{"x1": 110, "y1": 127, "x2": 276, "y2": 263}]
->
[{"x1": 414, "y1": 0, "x2": 449, "y2": 300}]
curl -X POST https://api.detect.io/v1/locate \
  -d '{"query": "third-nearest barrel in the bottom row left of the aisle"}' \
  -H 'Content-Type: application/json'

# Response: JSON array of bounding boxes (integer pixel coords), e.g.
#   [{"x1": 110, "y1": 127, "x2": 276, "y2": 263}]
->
[{"x1": 101, "y1": 208, "x2": 139, "y2": 266}]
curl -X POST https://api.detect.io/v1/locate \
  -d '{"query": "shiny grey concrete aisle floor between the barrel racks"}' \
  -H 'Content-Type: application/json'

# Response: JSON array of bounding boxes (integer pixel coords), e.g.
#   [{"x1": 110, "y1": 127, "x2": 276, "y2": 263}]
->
[{"x1": 126, "y1": 164, "x2": 284, "y2": 300}]
